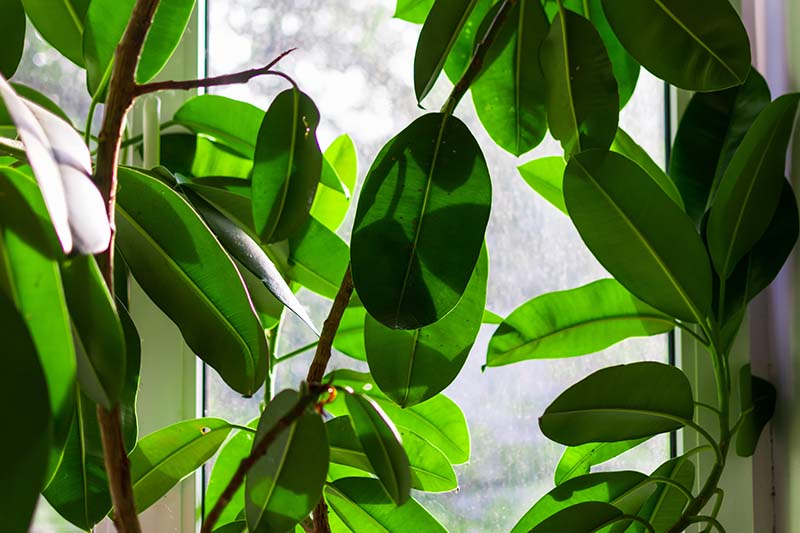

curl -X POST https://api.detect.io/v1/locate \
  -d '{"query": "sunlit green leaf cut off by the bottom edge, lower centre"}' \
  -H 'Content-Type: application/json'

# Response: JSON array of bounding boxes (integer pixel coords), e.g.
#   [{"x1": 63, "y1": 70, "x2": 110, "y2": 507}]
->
[{"x1": 325, "y1": 477, "x2": 447, "y2": 533}]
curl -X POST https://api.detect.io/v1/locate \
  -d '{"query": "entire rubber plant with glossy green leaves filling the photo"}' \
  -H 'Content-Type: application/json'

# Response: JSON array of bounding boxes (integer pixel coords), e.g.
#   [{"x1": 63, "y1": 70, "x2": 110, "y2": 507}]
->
[{"x1": 0, "y1": 0, "x2": 800, "y2": 533}]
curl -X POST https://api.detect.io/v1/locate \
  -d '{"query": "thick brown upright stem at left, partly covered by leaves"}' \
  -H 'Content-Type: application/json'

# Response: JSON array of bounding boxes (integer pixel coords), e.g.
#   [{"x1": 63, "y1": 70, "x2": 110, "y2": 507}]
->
[{"x1": 94, "y1": 0, "x2": 159, "y2": 533}]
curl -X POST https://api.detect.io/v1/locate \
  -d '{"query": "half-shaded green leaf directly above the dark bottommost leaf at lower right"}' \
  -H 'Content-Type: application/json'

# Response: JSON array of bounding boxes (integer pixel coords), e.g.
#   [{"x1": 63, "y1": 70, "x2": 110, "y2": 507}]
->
[{"x1": 511, "y1": 471, "x2": 647, "y2": 533}]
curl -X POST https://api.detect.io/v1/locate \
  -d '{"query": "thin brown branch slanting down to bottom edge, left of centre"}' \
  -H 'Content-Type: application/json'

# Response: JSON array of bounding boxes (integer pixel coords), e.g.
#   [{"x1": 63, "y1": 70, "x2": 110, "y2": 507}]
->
[{"x1": 200, "y1": 383, "x2": 328, "y2": 533}]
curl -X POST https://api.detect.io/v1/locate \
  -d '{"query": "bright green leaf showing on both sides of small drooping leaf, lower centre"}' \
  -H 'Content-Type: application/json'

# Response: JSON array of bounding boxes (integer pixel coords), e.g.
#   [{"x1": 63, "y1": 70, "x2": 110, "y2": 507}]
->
[{"x1": 325, "y1": 416, "x2": 458, "y2": 492}]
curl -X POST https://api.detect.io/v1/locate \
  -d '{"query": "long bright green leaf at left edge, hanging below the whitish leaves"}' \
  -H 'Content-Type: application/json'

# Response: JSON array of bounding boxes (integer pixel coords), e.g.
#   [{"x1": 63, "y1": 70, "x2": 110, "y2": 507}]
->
[{"x1": 0, "y1": 169, "x2": 76, "y2": 467}]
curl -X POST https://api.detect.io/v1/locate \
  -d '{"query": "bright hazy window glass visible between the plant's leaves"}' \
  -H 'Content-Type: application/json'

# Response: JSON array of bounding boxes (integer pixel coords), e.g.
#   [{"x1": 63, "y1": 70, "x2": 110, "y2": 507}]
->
[{"x1": 207, "y1": 0, "x2": 668, "y2": 531}]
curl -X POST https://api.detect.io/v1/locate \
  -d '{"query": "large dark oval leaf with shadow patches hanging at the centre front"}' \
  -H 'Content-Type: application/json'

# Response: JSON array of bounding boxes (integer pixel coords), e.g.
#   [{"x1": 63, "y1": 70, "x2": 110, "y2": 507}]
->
[{"x1": 351, "y1": 113, "x2": 492, "y2": 329}]
